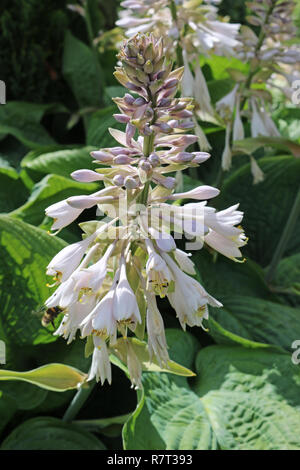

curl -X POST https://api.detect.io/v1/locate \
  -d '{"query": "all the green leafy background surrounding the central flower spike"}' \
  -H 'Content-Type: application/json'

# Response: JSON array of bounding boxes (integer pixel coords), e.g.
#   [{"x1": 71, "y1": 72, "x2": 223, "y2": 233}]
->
[{"x1": 0, "y1": 0, "x2": 300, "y2": 450}]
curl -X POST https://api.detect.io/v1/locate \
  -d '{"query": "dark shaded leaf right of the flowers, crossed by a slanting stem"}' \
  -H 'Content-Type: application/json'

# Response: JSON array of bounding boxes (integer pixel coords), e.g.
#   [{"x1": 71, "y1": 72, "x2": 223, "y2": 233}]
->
[{"x1": 216, "y1": 156, "x2": 300, "y2": 266}]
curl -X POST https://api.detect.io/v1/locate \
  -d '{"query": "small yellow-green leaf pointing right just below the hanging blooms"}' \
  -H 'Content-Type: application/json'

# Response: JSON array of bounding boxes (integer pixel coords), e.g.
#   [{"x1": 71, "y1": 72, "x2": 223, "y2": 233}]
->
[{"x1": 111, "y1": 338, "x2": 195, "y2": 377}]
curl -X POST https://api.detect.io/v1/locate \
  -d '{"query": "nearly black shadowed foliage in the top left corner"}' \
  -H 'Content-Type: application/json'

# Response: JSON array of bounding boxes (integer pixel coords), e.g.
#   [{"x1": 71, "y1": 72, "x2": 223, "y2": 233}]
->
[{"x1": 0, "y1": 0, "x2": 69, "y2": 103}]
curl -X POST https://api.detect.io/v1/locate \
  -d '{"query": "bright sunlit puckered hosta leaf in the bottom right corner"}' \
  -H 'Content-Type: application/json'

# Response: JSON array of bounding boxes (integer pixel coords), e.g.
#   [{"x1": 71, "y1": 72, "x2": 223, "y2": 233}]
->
[{"x1": 194, "y1": 346, "x2": 300, "y2": 450}]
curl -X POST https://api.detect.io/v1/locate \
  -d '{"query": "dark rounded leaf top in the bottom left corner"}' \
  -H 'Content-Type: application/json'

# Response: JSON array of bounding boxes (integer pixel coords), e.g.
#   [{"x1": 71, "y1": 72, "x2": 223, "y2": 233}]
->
[{"x1": 1, "y1": 418, "x2": 105, "y2": 450}]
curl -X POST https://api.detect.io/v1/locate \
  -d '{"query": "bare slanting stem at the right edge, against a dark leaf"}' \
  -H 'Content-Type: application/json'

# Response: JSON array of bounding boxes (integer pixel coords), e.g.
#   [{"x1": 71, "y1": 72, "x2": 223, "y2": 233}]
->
[{"x1": 266, "y1": 188, "x2": 300, "y2": 283}]
